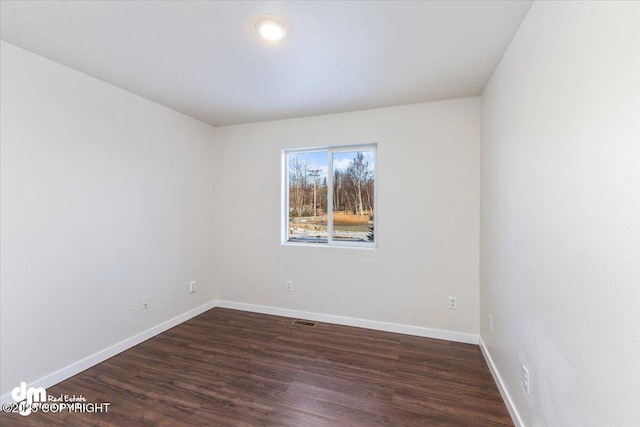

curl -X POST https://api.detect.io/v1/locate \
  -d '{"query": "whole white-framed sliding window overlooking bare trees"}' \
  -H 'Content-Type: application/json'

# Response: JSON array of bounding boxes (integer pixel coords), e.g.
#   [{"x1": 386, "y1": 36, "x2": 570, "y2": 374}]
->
[{"x1": 282, "y1": 144, "x2": 376, "y2": 247}]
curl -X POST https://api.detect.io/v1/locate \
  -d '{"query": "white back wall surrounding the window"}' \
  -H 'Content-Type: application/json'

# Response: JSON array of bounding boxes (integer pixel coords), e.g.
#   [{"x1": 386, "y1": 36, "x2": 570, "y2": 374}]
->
[{"x1": 216, "y1": 98, "x2": 480, "y2": 336}]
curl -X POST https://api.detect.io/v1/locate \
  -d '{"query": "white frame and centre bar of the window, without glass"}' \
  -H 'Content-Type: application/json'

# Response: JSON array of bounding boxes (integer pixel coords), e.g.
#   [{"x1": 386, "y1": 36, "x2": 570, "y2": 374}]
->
[{"x1": 281, "y1": 143, "x2": 379, "y2": 249}]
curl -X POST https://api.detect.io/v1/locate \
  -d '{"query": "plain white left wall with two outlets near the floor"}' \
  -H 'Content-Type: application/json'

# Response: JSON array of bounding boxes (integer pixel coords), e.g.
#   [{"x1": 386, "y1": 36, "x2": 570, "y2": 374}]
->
[{"x1": 0, "y1": 42, "x2": 215, "y2": 395}]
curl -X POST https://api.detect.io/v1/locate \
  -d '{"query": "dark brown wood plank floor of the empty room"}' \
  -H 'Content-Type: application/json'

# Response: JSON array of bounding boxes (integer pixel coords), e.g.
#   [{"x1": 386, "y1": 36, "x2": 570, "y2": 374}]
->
[{"x1": 0, "y1": 308, "x2": 513, "y2": 427}]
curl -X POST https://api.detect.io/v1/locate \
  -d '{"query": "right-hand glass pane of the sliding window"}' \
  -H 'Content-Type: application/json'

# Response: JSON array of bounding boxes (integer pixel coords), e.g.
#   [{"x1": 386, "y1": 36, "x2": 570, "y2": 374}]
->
[{"x1": 331, "y1": 150, "x2": 375, "y2": 242}]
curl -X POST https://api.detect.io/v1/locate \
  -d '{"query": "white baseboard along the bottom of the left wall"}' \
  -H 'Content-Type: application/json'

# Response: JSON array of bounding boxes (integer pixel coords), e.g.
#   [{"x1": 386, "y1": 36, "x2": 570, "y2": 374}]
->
[{"x1": 0, "y1": 300, "x2": 216, "y2": 404}]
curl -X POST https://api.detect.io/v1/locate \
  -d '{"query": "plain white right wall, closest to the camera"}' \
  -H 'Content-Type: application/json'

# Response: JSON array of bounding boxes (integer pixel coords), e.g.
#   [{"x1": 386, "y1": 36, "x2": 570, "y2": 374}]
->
[{"x1": 480, "y1": 2, "x2": 640, "y2": 426}]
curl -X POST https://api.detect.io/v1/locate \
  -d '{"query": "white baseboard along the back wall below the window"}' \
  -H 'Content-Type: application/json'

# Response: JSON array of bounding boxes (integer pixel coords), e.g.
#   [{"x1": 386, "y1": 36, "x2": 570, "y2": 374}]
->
[{"x1": 216, "y1": 300, "x2": 478, "y2": 345}]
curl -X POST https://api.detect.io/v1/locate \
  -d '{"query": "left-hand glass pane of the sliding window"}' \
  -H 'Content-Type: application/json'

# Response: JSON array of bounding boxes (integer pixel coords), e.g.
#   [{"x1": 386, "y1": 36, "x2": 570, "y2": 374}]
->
[{"x1": 287, "y1": 151, "x2": 329, "y2": 243}]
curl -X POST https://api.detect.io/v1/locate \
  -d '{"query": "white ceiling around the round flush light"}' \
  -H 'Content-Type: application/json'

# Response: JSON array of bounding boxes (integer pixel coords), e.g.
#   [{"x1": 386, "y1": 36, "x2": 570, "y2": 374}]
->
[{"x1": 0, "y1": 0, "x2": 531, "y2": 126}]
